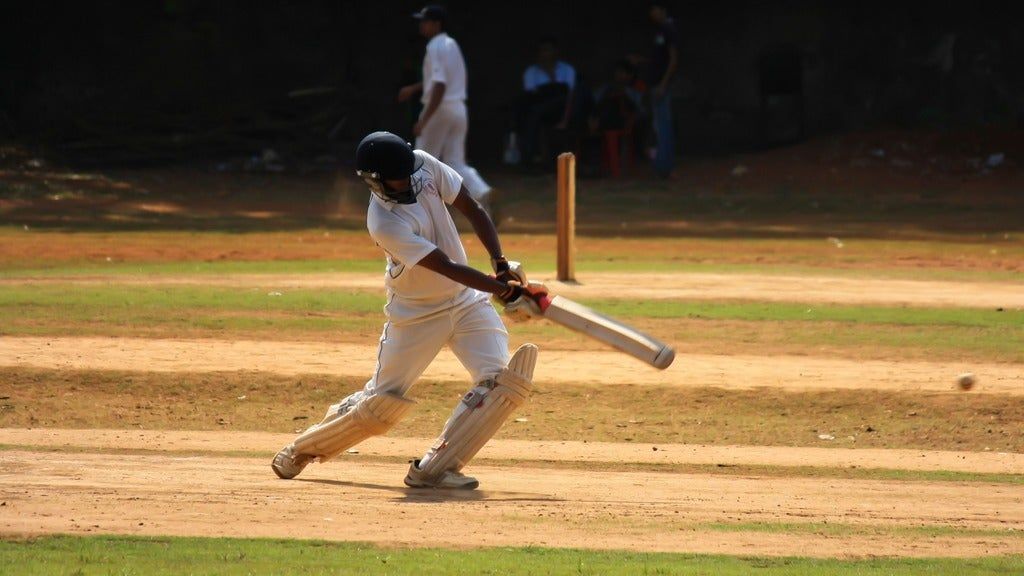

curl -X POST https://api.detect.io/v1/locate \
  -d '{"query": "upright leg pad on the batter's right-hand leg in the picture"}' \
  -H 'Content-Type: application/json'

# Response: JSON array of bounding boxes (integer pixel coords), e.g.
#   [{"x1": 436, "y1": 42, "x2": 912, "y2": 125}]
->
[{"x1": 420, "y1": 344, "x2": 537, "y2": 479}]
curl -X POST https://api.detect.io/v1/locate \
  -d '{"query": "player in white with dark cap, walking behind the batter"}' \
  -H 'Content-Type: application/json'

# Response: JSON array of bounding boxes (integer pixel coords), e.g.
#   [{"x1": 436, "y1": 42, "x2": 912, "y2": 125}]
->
[{"x1": 398, "y1": 5, "x2": 492, "y2": 206}]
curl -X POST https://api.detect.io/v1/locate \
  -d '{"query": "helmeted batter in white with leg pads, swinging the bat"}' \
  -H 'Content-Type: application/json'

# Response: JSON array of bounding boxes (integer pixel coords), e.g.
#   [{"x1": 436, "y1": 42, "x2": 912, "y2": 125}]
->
[{"x1": 271, "y1": 132, "x2": 540, "y2": 489}]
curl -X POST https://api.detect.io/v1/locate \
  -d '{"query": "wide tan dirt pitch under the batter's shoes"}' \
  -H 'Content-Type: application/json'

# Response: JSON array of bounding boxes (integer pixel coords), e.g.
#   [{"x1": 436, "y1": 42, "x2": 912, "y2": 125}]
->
[{"x1": 0, "y1": 430, "x2": 1024, "y2": 557}]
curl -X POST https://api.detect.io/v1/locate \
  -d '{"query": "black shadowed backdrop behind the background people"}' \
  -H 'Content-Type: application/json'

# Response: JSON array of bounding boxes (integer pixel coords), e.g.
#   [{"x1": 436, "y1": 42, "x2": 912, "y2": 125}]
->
[{"x1": 0, "y1": 0, "x2": 1024, "y2": 164}]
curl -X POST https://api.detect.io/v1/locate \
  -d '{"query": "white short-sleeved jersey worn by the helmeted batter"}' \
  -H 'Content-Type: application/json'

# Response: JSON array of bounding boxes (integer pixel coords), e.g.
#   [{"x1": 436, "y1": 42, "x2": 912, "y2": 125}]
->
[{"x1": 367, "y1": 150, "x2": 487, "y2": 323}]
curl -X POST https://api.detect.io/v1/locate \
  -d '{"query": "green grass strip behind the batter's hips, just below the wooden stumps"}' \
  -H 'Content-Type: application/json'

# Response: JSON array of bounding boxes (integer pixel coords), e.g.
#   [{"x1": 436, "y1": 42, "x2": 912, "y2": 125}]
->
[{"x1": 0, "y1": 284, "x2": 1024, "y2": 325}]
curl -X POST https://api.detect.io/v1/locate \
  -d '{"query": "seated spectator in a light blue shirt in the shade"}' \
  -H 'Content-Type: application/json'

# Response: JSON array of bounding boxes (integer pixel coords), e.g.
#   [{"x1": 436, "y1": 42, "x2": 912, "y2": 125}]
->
[{"x1": 515, "y1": 37, "x2": 577, "y2": 162}]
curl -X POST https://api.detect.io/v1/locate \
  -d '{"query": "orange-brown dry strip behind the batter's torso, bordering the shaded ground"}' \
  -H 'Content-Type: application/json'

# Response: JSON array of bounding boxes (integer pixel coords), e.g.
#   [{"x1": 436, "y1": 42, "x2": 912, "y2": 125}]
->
[{"x1": 0, "y1": 227, "x2": 1024, "y2": 283}]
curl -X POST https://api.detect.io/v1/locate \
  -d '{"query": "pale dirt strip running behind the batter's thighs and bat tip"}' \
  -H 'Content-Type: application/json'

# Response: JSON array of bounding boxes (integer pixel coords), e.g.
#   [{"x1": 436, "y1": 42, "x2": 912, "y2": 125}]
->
[{"x1": 0, "y1": 336, "x2": 1024, "y2": 396}]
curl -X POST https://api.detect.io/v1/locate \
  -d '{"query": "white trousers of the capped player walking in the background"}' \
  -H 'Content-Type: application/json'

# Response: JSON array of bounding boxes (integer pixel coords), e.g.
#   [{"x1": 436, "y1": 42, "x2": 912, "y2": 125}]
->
[{"x1": 416, "y1": 100, "x2": 490, "y2": 199}]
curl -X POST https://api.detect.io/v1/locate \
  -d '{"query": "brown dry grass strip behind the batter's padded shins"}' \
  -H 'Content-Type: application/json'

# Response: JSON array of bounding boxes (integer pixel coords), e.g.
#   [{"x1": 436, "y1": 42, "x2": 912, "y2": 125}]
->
[{"x1": 0, "y1": 368, "x2": 1024, "y2": 452}]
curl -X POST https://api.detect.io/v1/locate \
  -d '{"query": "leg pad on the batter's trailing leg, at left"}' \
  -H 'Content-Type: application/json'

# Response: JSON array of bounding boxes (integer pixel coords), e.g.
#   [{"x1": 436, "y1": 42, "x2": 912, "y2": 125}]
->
[{"x1": 295, "y1": 393, "x2": 415, "y2": 462}]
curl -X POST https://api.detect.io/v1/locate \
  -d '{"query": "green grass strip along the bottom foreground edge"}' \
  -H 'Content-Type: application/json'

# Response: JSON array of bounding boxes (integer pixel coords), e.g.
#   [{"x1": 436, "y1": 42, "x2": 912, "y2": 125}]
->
[{"x1": 0, "y1": 536, "x2": 1024, "y2": 576}]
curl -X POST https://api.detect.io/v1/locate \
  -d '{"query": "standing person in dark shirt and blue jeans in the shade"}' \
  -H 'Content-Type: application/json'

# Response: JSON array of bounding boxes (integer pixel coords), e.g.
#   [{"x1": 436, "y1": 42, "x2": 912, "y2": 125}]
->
[{"x1": 647, "y1": 2, "x2": 679, "y2": 177}]
